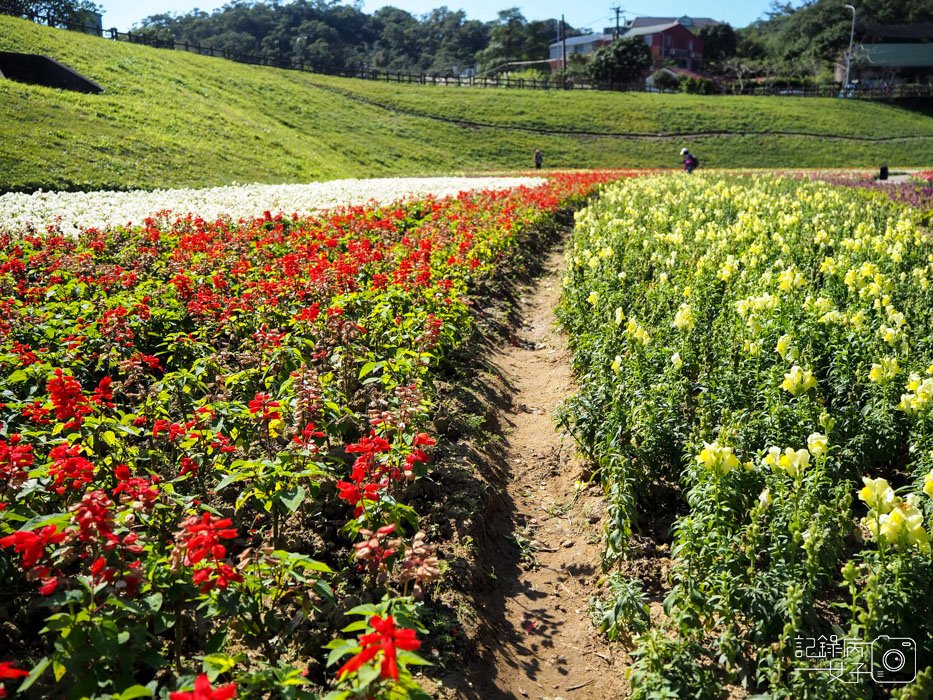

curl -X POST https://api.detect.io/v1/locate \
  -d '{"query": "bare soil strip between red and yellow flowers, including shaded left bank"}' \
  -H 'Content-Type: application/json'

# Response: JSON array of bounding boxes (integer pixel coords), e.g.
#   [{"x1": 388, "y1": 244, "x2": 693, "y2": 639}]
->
[{"x1": 428, "y1": 237, "x2": 636, "y2": 700}]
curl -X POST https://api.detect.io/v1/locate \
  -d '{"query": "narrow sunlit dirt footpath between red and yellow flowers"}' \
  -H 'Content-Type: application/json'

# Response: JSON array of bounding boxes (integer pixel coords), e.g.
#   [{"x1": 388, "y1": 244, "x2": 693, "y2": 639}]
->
[{"x1": 461, "y1": 239, "x2": 629, "y2": 700}]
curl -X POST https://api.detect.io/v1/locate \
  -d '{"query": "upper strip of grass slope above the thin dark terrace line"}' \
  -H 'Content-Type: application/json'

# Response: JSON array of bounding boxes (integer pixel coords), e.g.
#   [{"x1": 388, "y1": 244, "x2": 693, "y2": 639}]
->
[{"x1": 315, "y1": 76, "x2": 933, "y2": 140}]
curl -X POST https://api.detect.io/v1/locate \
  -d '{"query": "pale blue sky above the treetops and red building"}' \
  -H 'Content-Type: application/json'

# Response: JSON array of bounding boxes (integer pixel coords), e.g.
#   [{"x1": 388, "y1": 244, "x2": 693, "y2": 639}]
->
[{"x1": 97, "y1": 0, "x2": 768, "y2": 31}]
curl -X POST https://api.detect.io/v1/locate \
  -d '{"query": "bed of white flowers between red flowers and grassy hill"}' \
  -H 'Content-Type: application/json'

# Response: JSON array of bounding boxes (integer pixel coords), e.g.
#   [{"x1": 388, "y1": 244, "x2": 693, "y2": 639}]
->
[{"x1": 0, "y1": 177, "x2": 544, "y2": 235}]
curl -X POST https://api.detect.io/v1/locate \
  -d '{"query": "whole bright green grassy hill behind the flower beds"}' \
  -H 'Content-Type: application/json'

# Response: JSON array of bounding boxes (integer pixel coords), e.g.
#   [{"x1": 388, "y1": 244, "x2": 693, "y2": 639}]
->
[{"x1": 0, "y1": 16, "x2": 933, "y2": 192}]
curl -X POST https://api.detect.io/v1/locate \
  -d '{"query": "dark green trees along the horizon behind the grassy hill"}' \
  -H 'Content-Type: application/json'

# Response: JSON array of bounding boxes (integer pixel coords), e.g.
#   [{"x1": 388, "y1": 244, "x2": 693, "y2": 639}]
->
[{"x1": 0, "y1": 0, "x2": 933, "y2": 82}]
